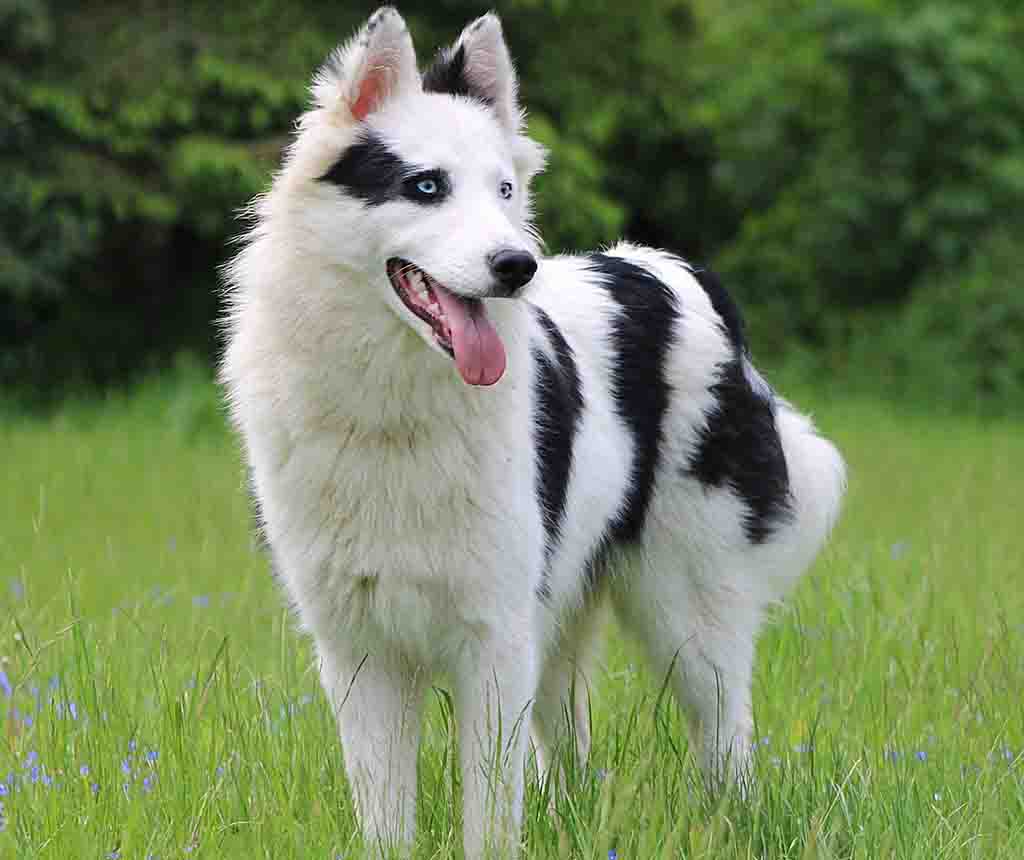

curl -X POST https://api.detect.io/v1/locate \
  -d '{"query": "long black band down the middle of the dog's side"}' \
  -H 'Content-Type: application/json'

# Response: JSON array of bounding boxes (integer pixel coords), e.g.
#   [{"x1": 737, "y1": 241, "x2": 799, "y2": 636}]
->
[{"x1": 589, "y1": 254, "x2": 679, "y2": 543}]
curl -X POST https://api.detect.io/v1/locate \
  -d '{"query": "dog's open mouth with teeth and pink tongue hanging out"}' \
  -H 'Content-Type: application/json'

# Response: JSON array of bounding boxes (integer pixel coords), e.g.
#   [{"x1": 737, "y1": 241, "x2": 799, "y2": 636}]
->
[{"x1": 387, "y1": 257, "x2": 505, "y2": 385}]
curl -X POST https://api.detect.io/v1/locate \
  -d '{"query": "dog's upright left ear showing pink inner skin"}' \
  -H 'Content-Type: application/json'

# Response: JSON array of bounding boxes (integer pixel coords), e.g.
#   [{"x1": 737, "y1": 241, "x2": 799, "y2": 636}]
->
[{"x1": 312, "y1": 6, "x2": 422, "y2": 122}]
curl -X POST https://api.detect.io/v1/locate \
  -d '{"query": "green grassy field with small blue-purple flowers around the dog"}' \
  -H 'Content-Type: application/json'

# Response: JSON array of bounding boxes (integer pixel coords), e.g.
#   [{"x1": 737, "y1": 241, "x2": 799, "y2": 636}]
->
[{"x1": 0, "y1": 383, "x2": 1024, "y2": 860}]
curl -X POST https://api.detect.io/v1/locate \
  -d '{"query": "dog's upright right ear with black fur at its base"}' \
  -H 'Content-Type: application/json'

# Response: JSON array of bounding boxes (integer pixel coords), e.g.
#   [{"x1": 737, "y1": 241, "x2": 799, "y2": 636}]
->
[{"x1": 423, "y1": 12, "x2": 522, "y2": 132}]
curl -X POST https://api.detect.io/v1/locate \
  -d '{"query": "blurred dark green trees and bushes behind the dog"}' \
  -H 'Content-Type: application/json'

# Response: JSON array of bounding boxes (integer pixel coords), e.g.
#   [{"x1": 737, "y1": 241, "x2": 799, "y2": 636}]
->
[{"x1": 0, "y1": 0, "x2": 1024, "y2": 410}]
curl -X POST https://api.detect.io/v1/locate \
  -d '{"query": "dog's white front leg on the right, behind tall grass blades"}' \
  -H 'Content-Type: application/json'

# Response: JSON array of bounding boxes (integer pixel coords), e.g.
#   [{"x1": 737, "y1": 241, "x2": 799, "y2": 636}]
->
[{"x1": 456, "y1": 624, "x2": 538, "y2": 860}]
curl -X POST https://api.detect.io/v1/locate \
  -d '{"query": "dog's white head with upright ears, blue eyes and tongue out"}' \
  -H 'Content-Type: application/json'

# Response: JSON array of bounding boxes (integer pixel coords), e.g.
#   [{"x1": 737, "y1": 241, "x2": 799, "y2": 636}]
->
[{"x1": 279, "y1": 7, "x2": 544, "y2": 385}]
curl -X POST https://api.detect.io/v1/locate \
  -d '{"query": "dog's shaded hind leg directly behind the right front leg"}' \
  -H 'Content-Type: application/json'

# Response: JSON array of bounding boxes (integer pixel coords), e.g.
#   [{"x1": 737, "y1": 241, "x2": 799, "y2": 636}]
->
[{"x1": 531, "y1": 601, "x2": 606, "y2": 779}]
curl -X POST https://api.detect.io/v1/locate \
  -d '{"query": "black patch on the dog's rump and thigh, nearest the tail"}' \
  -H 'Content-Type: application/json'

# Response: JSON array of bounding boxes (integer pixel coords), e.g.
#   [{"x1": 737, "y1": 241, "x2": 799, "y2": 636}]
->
[{"x1": 686, "y1": 269, "x2": 793, "y2": 544}]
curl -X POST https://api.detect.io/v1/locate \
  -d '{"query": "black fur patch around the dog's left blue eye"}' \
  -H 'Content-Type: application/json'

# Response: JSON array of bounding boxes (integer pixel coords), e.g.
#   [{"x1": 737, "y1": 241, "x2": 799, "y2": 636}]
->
[{"x1": 321, "y1": 130, "x2": 452, "y2": 206}]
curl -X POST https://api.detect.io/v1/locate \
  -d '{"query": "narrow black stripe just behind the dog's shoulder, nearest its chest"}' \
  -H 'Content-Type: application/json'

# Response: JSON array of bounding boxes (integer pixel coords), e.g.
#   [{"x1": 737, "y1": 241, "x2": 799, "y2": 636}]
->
[{"x1": 534, "y1": 307, "x2": 583, "y2": 598}]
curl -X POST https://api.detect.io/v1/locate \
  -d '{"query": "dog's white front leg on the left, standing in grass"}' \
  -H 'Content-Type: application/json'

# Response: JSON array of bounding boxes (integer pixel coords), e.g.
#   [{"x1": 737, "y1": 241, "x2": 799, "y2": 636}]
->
[{"x1": 321, "y1": 648, "x2": 426, "y2": 856}]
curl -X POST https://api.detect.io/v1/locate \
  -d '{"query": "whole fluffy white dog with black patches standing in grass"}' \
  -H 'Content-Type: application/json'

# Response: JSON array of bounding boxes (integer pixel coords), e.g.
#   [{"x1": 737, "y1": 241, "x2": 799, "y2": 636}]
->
[{"x1": 222, "y1": 7, "x2": 845, "y2": 858}]
